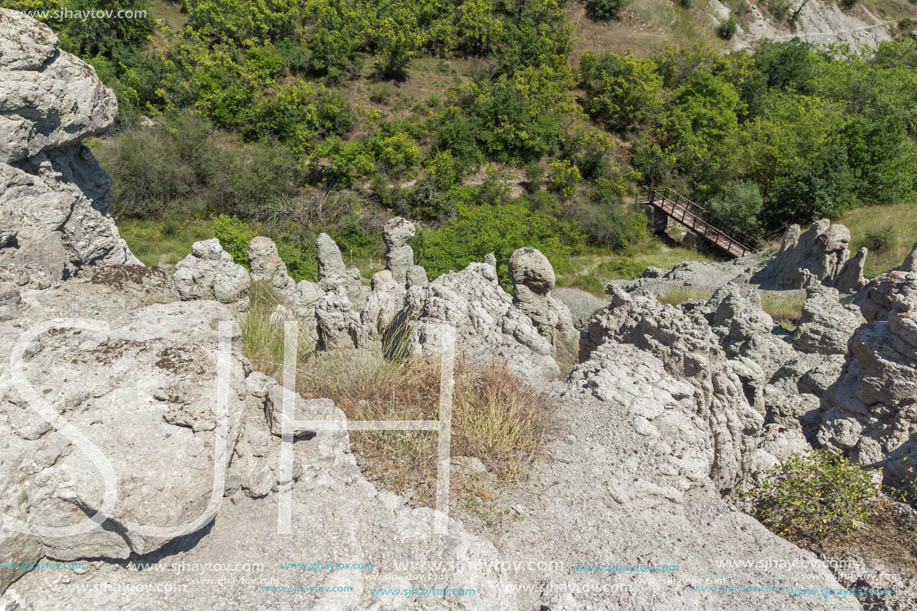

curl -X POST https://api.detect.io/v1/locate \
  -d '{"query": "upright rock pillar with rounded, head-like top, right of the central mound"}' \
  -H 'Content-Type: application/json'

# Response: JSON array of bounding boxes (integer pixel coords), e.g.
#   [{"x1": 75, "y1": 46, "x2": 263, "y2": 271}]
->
[{"x1": 509, "y1": 247, "x2": 579, "y2": 345}]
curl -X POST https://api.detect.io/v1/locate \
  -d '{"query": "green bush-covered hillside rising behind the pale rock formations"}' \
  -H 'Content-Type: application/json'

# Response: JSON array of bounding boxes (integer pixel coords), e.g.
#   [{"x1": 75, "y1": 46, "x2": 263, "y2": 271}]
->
[{"x1": 12, "y1": 0, "x2": 917, "y2": 278}]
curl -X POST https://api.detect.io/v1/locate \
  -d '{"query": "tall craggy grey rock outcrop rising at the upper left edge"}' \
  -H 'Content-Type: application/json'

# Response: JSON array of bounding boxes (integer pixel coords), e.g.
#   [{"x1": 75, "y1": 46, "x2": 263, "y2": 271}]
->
[{"x1": 0, "y1": 9, "x2": 139, "y2": 280}]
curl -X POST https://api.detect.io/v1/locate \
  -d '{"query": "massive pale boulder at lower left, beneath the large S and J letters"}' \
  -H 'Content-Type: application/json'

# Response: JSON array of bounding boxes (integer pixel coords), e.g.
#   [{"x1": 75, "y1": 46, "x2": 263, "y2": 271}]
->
[{"x1": 0, "y1": 290, "x2": 246, "y2": 561}]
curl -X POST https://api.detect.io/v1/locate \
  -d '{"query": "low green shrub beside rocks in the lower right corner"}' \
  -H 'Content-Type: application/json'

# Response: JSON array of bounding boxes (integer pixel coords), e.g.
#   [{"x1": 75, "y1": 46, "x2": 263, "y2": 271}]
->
[{"x1": 749, "y1": 450, "x2": 881, "y2": 541}]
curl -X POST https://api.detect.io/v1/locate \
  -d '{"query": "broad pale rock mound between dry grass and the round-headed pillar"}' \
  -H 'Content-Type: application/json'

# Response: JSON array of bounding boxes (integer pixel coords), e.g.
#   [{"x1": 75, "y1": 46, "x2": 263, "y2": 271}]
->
[{"x1": 384, "y1": 263, "x2": 559, "y2": 385}]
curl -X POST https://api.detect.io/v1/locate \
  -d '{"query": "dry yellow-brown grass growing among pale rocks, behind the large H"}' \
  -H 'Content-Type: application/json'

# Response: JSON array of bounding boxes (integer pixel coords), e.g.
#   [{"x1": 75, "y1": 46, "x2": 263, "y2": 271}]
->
[{"x1": 242, "y1": 294, "x2": 552, "y2": 508}]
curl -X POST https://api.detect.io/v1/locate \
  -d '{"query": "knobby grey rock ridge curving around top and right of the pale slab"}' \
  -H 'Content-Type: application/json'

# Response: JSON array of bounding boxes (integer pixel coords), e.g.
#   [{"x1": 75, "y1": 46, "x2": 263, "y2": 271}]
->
[{"x1": 580, "y1": 289, "x2": 764, "y2": 490}]
